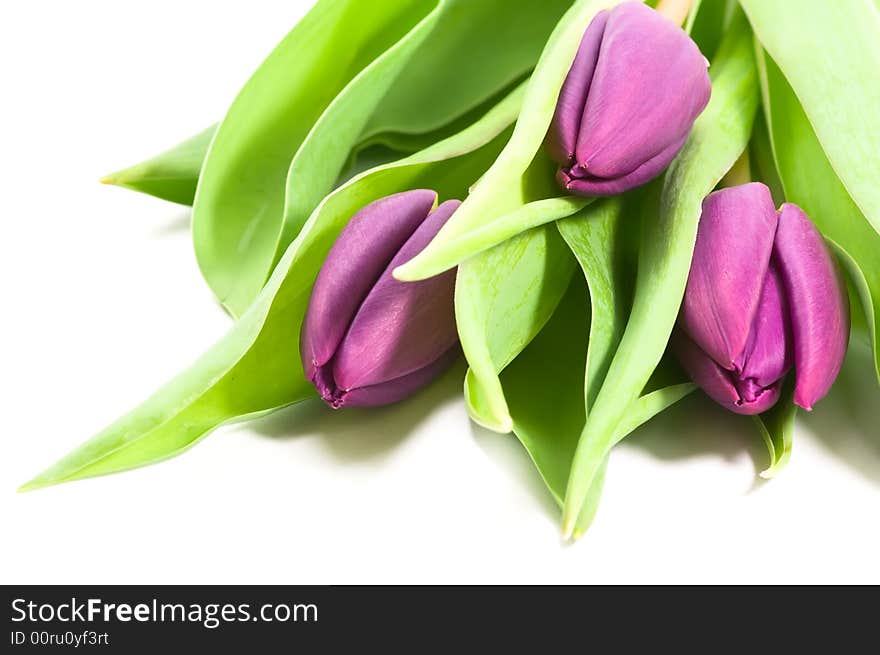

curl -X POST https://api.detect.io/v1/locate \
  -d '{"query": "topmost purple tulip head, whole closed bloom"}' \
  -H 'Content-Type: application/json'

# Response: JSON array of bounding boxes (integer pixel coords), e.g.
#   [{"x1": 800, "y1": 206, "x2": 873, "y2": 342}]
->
[{"x1": 548, "y1": 2, "x2": 712, "y2": 196}]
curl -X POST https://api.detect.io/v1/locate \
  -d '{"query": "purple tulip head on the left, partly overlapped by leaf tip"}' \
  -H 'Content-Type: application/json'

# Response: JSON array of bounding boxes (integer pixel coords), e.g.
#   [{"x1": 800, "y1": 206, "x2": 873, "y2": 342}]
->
[{"x1": 300, "y1": 189, "x2": 460, "y2": 409}]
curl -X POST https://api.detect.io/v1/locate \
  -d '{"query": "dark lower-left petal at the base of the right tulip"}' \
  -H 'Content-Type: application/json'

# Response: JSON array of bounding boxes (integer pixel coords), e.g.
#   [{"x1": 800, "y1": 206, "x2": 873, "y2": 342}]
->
[{"x1": 670, "y1": 329, "x2": 781, "y2": 415}]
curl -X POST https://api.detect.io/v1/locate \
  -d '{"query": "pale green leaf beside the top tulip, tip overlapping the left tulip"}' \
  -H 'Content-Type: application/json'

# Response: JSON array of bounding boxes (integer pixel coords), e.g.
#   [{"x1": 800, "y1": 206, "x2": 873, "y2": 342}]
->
[{"x1": 394, "y1": 0, "x2": 632, "y2": 280}]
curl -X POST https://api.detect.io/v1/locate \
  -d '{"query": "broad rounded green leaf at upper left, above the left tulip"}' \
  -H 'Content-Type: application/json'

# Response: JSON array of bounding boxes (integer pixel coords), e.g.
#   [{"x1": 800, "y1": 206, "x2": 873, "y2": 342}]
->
[{"x1": 193, "y1": 0, "x2": 444, "y2": 316}]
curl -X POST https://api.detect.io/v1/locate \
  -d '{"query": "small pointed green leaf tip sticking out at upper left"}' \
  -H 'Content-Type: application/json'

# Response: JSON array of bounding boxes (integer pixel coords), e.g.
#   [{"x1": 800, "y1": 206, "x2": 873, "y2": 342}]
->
[{"x1": 101, "y1": 125, "x2": 217, "y2": 205}]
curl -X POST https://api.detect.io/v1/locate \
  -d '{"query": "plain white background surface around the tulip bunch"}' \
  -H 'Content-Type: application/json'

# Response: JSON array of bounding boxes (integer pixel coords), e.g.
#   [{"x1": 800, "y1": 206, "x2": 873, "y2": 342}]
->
[{"x1": 0, "y1": 0, "x2": 880, "y2": 583}]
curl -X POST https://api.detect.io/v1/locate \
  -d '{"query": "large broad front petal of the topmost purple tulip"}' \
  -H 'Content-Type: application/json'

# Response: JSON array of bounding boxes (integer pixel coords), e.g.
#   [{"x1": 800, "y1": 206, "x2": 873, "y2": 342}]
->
[{"x1": 575, "y1": 2, "x2": 711, "y2": 179}]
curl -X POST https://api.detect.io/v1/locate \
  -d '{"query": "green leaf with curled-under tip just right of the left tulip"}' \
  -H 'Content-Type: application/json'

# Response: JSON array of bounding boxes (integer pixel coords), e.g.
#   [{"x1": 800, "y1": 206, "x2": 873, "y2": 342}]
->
[{"x1": 455, "y1": 225, "x2": 574, "y2": 432}]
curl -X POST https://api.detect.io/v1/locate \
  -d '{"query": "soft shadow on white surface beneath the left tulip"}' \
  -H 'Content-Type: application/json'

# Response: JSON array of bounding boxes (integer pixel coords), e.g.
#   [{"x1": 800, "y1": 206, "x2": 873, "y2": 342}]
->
[{"x1": 245, "y1": 361, "x2": 465, "y2": 463}]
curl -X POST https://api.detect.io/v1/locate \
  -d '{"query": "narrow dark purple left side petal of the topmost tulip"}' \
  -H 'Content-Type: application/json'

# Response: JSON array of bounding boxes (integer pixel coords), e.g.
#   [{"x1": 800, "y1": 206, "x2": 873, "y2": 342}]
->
[{"x1": 547, "y1": 10, "x2": 608, "y2": 165}]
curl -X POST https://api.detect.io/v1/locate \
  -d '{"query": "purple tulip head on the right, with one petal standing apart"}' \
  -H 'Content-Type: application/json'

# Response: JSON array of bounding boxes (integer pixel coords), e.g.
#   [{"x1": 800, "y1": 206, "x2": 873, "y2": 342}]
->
[{"x1": 672, "y1": 182, "x2": 849, "y2": 414}]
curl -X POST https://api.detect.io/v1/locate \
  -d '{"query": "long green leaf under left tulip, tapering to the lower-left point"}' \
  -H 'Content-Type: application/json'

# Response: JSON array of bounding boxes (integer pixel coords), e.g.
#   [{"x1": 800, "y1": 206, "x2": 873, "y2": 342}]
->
[{"x1": 22, "y1": 93, "x2": 521, "y2": 489}]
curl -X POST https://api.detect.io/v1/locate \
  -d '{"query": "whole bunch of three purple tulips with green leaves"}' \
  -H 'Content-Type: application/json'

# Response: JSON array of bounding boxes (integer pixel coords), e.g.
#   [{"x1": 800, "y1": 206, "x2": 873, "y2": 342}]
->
[{"x1": 23, "y1": 0, "x2": 880, "y2": 538}]
